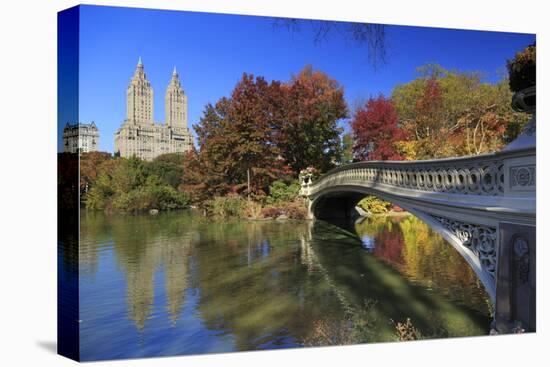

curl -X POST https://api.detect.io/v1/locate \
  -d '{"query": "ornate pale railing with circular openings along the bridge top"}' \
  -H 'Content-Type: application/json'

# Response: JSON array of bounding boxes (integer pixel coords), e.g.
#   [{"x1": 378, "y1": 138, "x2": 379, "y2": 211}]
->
[{"x1": 301, "y1": 149, "x2": 536, "y2": 212}]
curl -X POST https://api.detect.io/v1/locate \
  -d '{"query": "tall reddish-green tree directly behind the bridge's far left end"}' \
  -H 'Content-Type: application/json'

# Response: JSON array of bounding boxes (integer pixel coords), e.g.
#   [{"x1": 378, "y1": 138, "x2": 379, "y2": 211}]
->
[{"x1": 273, "y1": 66, "x2": 348, "y2": 174}]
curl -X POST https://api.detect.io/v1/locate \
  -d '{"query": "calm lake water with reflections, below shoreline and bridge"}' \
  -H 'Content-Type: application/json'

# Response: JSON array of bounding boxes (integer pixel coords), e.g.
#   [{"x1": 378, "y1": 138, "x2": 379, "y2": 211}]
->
[{"x1": 68, "y1": 211, "x2": 491, "y2": 360}]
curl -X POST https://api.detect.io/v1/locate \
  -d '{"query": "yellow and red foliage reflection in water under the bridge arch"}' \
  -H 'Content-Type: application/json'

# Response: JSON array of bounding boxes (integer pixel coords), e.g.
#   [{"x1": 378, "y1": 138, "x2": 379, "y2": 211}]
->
[{"x1": 356, "y1": 215, "x2": 490, "y2": 313}]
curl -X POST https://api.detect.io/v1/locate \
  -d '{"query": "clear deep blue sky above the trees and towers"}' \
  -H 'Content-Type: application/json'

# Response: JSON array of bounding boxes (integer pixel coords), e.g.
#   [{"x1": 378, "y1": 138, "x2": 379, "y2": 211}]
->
[{"x1": 59, "y1": 6, "x2": 535, "y2": 152}]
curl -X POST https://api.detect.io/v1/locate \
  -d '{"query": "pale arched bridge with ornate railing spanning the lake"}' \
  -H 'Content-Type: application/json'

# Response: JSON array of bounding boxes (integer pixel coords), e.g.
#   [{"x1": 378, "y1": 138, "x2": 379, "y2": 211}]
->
[{"x1": 301, "y1": 143, "x2": 536, "y2": 333}]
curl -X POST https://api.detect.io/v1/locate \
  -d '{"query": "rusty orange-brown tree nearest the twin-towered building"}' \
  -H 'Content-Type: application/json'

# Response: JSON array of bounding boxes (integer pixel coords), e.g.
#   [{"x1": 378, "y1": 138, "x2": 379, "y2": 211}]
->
[{"x1": 183, "y1": 74, "x2": 292, "y2": 201}]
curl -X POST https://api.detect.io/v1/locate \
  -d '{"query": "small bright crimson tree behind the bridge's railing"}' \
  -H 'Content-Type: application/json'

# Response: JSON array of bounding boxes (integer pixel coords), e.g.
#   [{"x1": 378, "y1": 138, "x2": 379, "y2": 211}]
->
[{"x1": 351, "y1": 95, "x2": 405, "y2": 160}]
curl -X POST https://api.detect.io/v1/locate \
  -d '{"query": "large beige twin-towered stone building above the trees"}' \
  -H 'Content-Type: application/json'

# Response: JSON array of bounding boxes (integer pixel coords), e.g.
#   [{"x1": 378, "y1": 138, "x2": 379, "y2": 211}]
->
[{"x1": 115, "y1": 59, "x2": 193, "y2": 160}]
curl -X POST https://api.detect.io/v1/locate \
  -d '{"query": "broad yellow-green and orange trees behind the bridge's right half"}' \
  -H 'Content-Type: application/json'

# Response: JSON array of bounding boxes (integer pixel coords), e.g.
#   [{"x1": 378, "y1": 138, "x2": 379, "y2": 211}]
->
[{"x1": 392, "y1": 65, "x2": 527, "y2": 159}]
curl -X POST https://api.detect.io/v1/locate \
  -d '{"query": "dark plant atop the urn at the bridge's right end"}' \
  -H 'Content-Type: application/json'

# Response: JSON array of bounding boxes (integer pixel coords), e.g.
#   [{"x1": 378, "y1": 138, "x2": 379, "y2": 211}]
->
[{"x1": 507, "y1": 44, "x2": 537, "y2": 92}]
